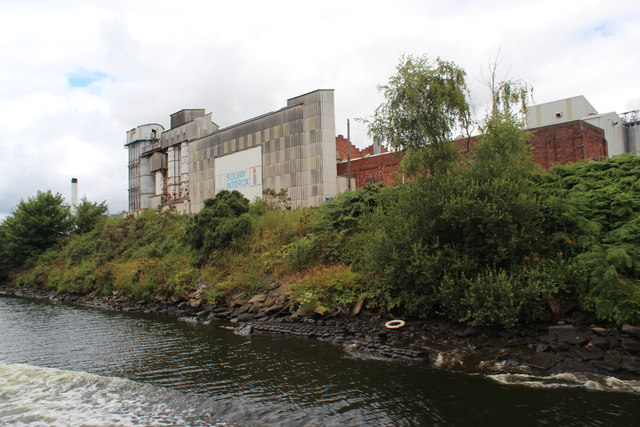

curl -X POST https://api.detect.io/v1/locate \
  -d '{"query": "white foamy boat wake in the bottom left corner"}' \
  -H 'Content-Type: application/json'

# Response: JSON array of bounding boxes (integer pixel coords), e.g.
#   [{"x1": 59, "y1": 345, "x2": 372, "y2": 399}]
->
[{"x1": 0, "y1": 363, "x2": 226, "y2": 426}]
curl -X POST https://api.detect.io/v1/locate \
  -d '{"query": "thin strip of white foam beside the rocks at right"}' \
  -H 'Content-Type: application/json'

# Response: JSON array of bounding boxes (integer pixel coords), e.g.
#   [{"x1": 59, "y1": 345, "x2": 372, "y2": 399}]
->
[{"x1": 487, "y1": 373, "x2": 640, "y2": 393}]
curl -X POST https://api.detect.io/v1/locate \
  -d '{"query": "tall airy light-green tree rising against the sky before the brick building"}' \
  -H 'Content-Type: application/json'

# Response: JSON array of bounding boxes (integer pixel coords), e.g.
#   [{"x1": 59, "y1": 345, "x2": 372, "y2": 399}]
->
[{"x1": 367, "y1": 56, "x2": 470, "y2": 175}]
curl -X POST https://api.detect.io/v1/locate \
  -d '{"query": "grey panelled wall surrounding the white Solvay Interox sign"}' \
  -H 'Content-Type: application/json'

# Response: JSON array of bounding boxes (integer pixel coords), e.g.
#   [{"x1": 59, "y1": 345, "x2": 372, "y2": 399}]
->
[{"x1": 189, "y1": 90, "x2": 336, "y2": 212}]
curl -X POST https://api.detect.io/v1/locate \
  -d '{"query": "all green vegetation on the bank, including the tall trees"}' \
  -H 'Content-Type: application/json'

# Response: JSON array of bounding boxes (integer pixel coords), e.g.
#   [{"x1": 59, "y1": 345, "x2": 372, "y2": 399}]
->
[{"x1": 0, "y1": 58, "x2": 640, "y2": 327}]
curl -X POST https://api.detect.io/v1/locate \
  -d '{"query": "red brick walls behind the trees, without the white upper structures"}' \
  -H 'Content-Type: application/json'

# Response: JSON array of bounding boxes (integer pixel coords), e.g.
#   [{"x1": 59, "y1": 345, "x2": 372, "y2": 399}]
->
[{"x1": 336, "y1": 120, "x2": 608, "y2": 187}]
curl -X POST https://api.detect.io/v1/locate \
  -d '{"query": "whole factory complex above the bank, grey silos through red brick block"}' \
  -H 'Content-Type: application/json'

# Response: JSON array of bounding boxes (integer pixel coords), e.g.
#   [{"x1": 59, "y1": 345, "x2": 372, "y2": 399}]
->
[{"x1": 125, "y1": 93, "x2": 640, "y2": 213}]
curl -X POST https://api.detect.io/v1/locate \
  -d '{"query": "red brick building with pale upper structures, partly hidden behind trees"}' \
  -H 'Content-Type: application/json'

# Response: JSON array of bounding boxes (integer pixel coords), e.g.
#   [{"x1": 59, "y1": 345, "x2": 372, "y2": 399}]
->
[{"x1": 336, "y1": 95, "x2": 640, "y2": 188}]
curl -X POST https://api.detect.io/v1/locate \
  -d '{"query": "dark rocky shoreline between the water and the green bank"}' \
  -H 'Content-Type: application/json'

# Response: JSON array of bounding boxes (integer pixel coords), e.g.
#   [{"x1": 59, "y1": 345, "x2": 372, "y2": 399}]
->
[{"x1": 0, "y1": 285, "x2": 640, "y2": 380}]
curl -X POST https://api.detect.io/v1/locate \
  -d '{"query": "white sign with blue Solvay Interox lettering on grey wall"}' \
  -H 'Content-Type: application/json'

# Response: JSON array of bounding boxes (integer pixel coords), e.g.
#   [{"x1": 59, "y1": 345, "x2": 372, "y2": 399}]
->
[{"x1": 214, "y1": 147, "x2": 262, "y2": 201}]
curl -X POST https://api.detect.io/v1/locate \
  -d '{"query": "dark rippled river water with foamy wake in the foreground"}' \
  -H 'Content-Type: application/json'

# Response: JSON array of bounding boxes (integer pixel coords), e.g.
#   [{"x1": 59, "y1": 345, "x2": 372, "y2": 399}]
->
[{"x1": 0, "y1": 297, "x2": 640, "y2": 426}]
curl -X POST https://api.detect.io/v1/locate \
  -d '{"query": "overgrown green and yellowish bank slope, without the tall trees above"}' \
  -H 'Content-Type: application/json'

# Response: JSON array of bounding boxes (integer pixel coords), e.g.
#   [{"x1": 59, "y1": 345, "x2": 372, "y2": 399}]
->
[{"x1": 7, "y1": 155, "x2": 640, "y2": 326}]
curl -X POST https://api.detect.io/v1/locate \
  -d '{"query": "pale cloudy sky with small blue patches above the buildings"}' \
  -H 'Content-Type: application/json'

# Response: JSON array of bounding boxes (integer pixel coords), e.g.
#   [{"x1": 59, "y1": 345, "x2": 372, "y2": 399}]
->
[{"x1": 0, "y1": 0, "x2": 640, "y2": 218}]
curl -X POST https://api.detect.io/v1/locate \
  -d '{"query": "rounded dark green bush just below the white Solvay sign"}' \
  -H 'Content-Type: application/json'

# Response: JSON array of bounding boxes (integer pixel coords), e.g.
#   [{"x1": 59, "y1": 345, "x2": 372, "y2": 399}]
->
[{"x1": 184, "y1": 190, "x2": 251, "y2": 264}]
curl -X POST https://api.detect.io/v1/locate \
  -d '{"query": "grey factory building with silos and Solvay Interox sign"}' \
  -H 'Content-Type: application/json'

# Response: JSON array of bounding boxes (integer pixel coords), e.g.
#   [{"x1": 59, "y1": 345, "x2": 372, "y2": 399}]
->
[{"x1": 125, "y1": 90, "x2": 338, "y2": 213}]
